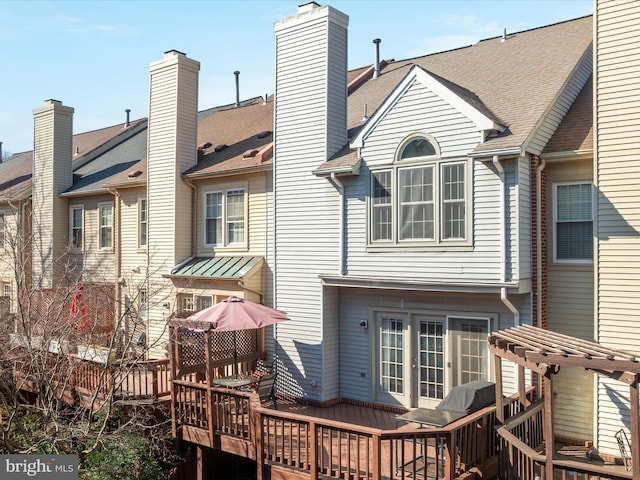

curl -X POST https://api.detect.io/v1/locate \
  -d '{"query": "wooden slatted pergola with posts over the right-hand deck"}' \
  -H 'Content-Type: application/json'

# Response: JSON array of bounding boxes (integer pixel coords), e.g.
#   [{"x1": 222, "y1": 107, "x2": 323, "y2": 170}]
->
[{"x1": 489, "y1": 325, "x2": 640, "y2": 478}]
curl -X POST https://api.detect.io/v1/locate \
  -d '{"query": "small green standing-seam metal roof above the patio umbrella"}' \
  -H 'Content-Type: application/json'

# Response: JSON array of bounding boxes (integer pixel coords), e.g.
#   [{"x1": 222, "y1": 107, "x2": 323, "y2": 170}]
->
[{"x1": 170, "y1": 256, "x2": 264, "y2": 279}]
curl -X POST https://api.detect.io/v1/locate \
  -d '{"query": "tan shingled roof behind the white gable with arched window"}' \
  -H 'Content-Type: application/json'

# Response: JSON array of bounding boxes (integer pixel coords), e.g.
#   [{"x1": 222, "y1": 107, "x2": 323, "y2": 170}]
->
[{"x1": 316, "y1": 16, "x2": 593, "y2": 173}]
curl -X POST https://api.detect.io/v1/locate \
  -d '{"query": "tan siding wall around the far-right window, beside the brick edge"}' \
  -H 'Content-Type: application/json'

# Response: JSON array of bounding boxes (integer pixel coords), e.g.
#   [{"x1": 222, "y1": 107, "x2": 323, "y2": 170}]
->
[{"x1": 546, "y1": 159, "x2": 594, "y2": 441}]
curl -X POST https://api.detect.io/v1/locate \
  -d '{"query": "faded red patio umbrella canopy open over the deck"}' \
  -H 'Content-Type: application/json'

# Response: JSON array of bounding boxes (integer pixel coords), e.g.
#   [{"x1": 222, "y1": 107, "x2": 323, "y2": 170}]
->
[{"x1": 185, "y1": 297, "x2": 289, "y2": 332}]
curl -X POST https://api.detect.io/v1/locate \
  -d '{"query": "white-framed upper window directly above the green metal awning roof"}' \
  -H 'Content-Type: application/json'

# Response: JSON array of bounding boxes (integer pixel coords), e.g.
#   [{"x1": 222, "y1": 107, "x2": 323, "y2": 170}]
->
[{"x1": 204, "y1": 188, "x2": 247, "y2": 247}]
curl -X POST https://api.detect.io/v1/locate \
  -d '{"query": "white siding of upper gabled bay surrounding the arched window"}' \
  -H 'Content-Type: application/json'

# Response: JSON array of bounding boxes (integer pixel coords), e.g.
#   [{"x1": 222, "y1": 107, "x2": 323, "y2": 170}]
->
[{"x1": 346, "y1": 82, "x2": 530, "y2": 282}]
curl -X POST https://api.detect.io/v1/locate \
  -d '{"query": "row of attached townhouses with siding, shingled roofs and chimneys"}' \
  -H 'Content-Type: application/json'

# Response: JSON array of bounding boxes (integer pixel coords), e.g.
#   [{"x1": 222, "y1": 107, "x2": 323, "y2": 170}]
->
[{"x1": 5, "y1": 1, "x2": 638, "y2": 464}]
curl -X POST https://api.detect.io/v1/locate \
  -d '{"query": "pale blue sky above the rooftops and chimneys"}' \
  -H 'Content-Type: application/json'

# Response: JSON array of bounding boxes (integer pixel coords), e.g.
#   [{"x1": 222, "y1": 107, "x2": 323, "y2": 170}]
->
[{"x1": 0, "y1": 0, "x2": 593, "y2": 154}]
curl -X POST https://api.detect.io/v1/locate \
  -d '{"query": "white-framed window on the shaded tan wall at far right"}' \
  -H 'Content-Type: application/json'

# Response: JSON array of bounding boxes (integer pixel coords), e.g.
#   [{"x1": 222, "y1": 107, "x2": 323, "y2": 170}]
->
[{"x1": 553, "y1": 183, "x2": 593, "y2": 263}]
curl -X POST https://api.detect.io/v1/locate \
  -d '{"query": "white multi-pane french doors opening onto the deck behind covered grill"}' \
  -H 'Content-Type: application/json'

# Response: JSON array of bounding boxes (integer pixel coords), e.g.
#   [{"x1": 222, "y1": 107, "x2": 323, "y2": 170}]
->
[{"x1": 375, "y1": 312, "x2": 490, "y2": 408}]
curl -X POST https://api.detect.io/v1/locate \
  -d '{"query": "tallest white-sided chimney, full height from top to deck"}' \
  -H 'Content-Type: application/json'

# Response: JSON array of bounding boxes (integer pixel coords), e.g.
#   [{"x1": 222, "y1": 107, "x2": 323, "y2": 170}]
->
[{"x1": 274, "y1": 7, "x2": 347, "y2": 399}]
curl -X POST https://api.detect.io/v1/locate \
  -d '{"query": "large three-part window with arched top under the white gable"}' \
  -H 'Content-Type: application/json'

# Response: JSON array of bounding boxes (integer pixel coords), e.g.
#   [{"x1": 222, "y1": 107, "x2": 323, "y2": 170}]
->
[{"x1": 369, "y1": 137, "x2": 469, "y2": 245}]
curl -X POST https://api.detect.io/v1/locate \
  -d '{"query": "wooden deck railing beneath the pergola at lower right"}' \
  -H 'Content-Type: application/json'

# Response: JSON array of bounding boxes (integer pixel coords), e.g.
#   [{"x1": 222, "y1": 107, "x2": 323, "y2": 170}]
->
[{"x1": 496, "y1": 399, "x2": 632, "y2": 480}]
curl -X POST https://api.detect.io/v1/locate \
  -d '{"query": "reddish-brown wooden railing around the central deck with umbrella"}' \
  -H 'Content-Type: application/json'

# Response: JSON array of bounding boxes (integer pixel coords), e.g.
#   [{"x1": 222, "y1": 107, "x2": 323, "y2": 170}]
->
[{"x1": 173, "y1": 380, "x2": 533, "y2": 480}]
